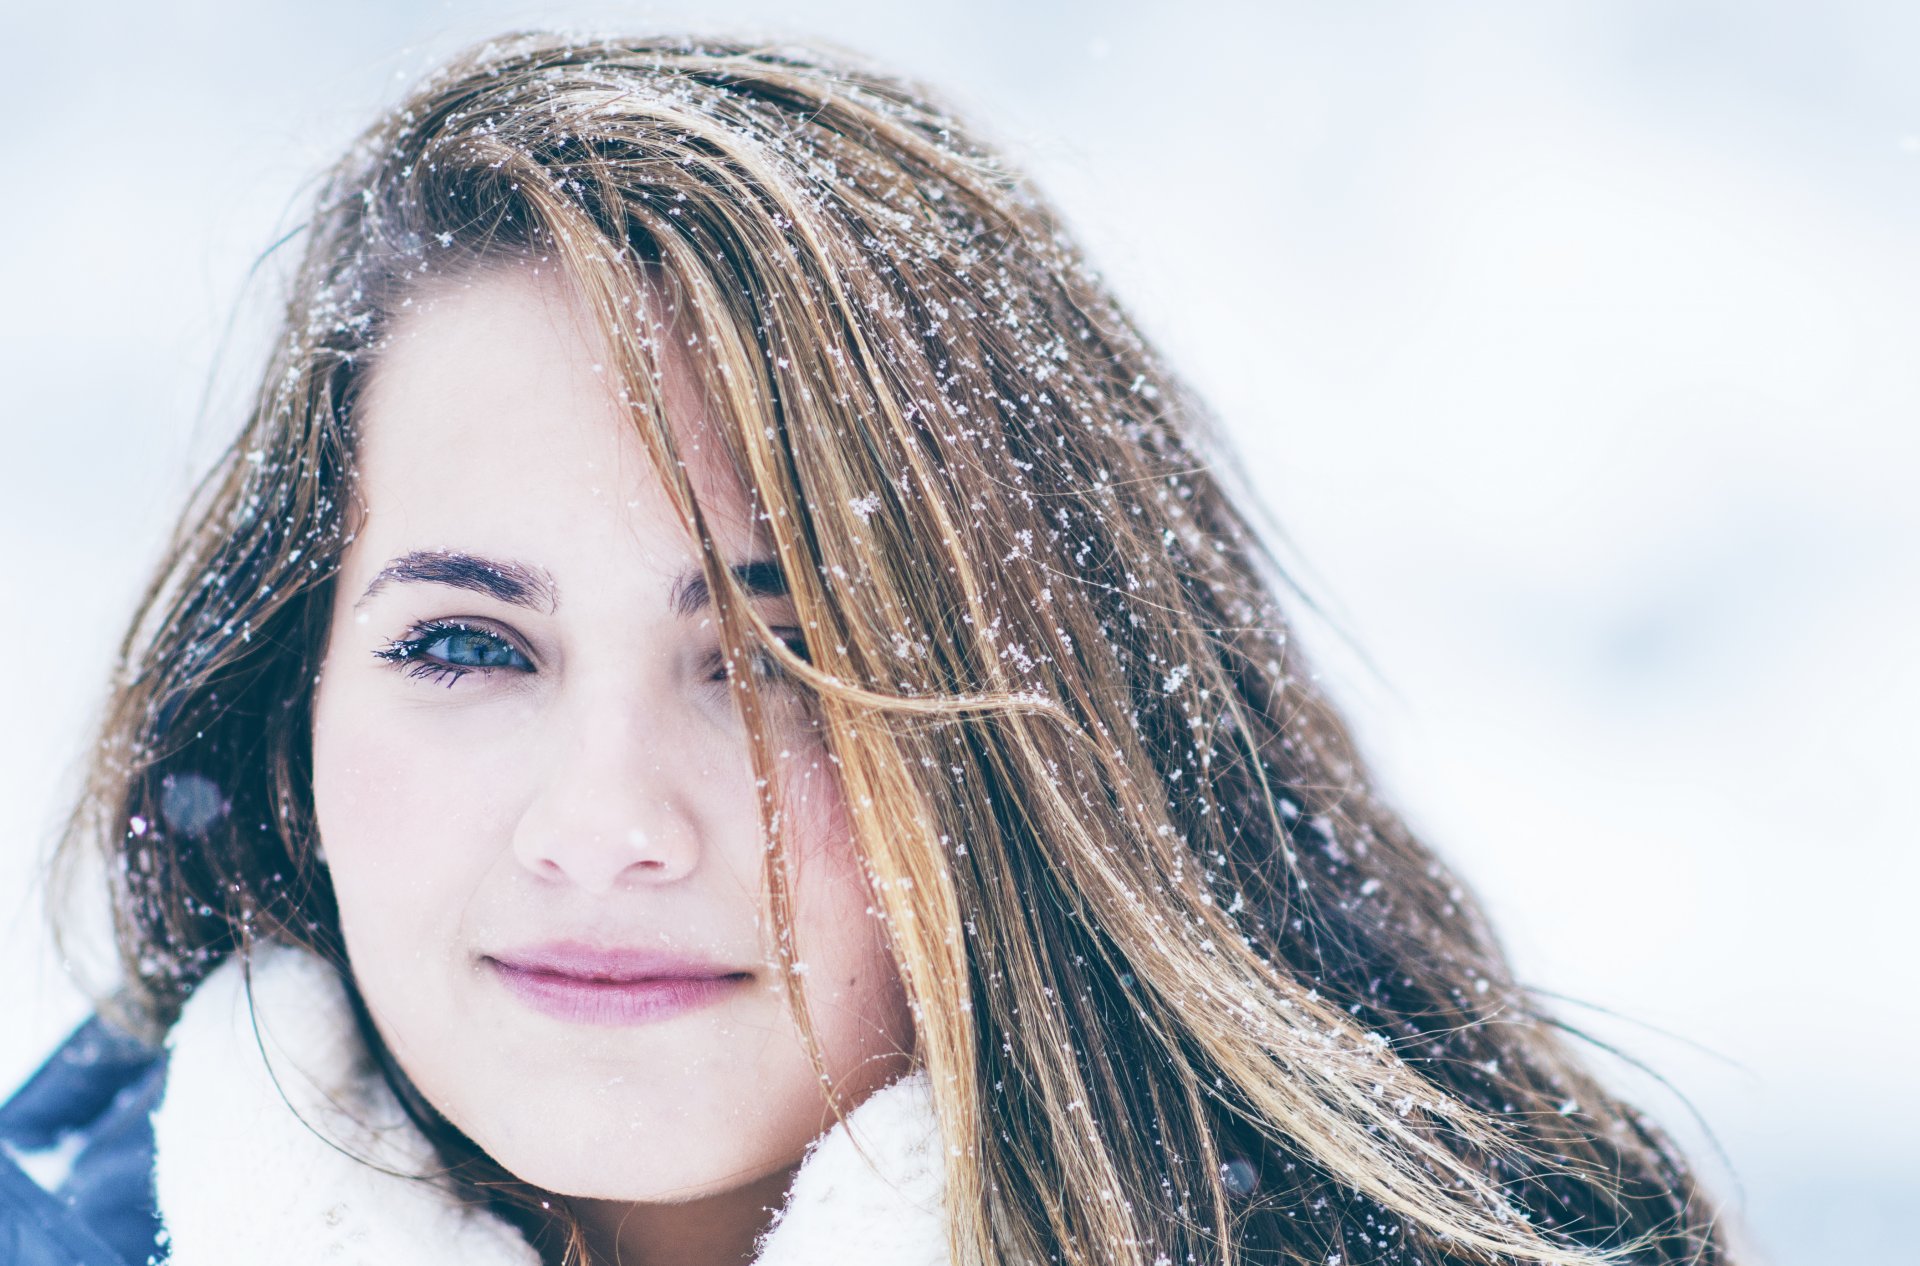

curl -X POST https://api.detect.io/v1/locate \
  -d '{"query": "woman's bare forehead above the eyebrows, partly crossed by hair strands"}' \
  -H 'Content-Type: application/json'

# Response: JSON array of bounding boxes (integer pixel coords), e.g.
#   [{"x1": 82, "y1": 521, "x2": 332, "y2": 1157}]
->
[{"x1": 355, "y1": 265, "x2": 753, "y2": 557}]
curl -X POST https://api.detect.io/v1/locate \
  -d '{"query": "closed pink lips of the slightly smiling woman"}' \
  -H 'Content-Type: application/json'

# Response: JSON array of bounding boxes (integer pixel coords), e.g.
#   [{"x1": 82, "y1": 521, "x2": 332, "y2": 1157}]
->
[{"x1": 480, "y1": 941, "x2": 749, "y2": 1024}]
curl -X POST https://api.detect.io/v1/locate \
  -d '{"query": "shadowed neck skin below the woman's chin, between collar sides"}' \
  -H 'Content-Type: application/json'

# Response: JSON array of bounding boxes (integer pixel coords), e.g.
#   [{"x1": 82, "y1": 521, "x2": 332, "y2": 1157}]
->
[{"x1": 566, "y1": 1162, "x2": 799, "y2": 1266}]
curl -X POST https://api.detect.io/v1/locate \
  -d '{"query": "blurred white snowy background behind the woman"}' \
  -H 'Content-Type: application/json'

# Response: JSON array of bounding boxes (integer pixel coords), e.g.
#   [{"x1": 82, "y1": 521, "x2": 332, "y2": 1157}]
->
[{"x1": 0, "y1": 0, "x2": 1920, "y2": 1266}]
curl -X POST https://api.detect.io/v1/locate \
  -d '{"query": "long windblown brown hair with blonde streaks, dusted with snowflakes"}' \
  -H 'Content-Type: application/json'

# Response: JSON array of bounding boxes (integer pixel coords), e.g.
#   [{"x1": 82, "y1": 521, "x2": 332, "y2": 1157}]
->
[{"x1": 63, "y1": 35, "x2": 1730, "y2": 1266}]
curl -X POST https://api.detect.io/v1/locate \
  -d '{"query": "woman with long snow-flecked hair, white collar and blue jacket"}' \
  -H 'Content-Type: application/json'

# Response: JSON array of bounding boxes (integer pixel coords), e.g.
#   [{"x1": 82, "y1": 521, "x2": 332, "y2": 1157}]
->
[{"x1": 0, "y1": 37, "x2": 1728, "y2": 1266}]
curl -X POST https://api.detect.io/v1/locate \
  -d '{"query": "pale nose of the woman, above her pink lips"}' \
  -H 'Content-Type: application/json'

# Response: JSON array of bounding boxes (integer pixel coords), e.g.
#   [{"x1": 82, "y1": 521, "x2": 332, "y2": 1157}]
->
[{"x1": 513, "y1": 699, "x2": 703, "y2": 891}]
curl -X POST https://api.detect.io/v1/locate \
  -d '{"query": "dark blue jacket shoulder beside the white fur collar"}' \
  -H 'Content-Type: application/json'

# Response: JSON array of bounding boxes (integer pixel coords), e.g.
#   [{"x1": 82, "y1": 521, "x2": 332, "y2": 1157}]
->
[{"x1": 0, "y1": 1016, "x2": 167, "y2": 1266}]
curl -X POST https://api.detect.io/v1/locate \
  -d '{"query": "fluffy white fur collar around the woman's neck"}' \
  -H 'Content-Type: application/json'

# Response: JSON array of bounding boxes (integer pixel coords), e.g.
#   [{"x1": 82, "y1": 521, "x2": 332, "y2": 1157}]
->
[{"x1": 154, "y1": 947, "x2": 948, "y2": 1266}]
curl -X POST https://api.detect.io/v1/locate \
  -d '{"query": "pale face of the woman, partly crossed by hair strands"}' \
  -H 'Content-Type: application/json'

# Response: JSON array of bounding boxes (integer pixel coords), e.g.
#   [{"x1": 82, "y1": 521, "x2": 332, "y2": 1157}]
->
[{"x1": 313, "y1": 267, "x2": 912, "y2": 1203}]
